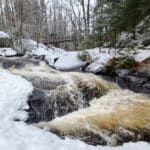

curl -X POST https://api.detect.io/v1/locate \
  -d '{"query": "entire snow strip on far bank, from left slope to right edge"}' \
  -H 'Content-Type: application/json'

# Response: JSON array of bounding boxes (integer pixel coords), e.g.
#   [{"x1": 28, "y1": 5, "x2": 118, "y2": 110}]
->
[{"x1": 28, "y1": 40, "x2": 150, "y2": 72}]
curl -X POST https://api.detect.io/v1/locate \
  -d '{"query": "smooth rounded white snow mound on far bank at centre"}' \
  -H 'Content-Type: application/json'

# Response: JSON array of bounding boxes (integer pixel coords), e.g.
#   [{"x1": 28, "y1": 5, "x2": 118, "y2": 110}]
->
[{"x1": 54, "y1": 52, "x2": 85, "y2": 70}]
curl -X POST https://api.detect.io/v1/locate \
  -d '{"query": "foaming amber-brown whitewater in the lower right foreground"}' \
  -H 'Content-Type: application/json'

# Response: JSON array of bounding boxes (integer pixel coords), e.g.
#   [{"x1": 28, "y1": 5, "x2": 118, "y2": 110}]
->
[{"x1": 37, "y1": 89, "x2": 150, "y2": 145}]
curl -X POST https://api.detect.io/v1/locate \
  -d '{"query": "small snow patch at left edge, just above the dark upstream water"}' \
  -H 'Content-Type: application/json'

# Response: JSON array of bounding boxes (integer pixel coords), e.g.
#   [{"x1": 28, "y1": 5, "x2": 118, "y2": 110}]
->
[{"x1": 0, "y1": 48, "x2": 17, "y2": 56}]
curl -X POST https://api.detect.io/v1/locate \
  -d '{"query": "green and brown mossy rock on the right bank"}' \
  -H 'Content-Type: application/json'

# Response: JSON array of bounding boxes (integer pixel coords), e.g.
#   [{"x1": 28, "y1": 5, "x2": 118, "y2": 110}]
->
[{"x1": 106, "y1": 57, "x2": 137, "y2": 69}]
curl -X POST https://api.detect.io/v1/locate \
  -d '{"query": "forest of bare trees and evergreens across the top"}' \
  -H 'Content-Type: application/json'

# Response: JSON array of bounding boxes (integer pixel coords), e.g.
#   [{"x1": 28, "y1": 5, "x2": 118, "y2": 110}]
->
[{"x1": 0, "y1": 0, "x2": 150, "y2": 50}]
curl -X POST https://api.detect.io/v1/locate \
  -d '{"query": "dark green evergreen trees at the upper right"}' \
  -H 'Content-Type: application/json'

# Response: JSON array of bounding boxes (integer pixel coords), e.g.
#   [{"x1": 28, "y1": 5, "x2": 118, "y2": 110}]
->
[{"x1": 94, "y1": 0, "x2": 150, "y2": 46}]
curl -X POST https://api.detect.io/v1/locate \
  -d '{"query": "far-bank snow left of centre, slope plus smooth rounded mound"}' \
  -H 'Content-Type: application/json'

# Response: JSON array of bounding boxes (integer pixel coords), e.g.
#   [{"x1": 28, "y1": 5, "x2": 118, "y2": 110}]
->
[{"x1": 24, "y1": 40, "x2": 85, "y2": 70}]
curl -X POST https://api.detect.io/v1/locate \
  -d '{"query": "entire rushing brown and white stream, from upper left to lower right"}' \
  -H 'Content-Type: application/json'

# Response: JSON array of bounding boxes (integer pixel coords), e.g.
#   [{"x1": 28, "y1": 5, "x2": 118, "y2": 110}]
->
[{"x1": 0, "y1": 58, "x2": 150, "y2": 145}]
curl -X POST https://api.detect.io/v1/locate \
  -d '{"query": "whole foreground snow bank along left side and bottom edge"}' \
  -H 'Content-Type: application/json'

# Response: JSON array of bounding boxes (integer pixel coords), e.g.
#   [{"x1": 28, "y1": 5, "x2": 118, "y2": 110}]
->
[{"x1": 0, "y1": 71, "x2": 150, "y2": 150}]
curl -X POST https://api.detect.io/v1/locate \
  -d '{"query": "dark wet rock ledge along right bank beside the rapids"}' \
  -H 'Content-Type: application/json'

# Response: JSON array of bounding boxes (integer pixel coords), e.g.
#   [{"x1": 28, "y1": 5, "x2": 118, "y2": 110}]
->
[{"x1": 97, "y1": 68, "x2": 150, "y2": 94}]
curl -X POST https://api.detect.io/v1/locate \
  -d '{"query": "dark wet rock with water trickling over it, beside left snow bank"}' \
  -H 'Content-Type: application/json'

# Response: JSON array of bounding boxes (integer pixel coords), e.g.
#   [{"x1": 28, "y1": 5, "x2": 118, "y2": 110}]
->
[{"x1": 25, "y1": 77, "x2": 102, "y2": 123}]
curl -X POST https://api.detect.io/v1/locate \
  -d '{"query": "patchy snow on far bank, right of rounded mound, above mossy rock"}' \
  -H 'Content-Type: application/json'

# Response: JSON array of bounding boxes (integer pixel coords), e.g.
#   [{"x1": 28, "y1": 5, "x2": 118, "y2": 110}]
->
[{"x1": 83, "y1": 48, "x2": 150, "y2": 72}]
